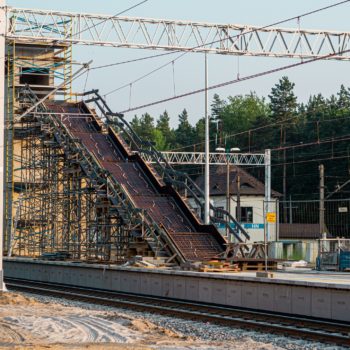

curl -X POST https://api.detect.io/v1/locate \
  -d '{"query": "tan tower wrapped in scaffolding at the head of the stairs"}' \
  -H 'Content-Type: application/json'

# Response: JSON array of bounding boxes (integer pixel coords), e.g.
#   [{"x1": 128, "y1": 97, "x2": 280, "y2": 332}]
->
[{"x1": 4, "y1": 34, "x2": 77, "y2": 255}]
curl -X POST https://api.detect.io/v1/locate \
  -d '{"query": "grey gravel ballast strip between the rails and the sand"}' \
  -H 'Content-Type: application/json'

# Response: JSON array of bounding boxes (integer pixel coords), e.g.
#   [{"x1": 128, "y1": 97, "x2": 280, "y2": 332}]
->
[{"x1": 13, "y1": 293, "x2": 345, "y2": 350}]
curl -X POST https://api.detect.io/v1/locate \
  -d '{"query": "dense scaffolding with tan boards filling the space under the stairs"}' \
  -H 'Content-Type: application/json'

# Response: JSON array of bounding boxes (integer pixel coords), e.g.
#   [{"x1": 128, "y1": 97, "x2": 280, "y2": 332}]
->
[{"x1": 8, "y1": 89, "x2": 129, "y2": 262}]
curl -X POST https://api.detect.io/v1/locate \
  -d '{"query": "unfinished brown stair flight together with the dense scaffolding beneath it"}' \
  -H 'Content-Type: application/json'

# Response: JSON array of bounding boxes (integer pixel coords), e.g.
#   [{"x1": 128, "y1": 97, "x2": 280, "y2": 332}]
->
[{"x1": 7, "y1": 86, "x2": 249, "y2": 264}]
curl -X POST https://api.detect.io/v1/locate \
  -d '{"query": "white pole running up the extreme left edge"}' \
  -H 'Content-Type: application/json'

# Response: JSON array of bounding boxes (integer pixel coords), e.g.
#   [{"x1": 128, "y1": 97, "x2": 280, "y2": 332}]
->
[{"x1": 0, "y1": 0, "x2": 6, "y2": 291}]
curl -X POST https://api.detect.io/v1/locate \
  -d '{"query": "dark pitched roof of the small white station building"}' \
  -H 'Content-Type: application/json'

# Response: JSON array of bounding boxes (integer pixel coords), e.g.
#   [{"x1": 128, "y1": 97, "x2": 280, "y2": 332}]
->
[{"x1": 196, "y1": 165, "x2": 281, "y2": 197}]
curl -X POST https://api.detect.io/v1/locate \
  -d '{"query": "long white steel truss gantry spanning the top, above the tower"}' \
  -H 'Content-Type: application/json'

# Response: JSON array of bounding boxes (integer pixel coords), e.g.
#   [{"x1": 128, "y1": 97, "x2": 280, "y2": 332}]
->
[{"x1": 6, "y1": 7, "x2": 350, "y2": 60}]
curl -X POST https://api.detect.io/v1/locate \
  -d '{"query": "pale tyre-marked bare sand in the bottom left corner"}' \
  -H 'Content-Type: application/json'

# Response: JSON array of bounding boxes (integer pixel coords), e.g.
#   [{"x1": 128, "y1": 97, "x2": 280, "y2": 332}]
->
[{"x1": 0, "y1": 293, "x2": 191, "y2": 349}]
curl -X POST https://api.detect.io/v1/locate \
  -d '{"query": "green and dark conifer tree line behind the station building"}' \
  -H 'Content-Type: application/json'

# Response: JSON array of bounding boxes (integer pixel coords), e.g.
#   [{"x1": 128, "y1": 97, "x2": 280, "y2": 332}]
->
[{"x1": 131, "y1": 77, "x2": 350, "y2": 200}]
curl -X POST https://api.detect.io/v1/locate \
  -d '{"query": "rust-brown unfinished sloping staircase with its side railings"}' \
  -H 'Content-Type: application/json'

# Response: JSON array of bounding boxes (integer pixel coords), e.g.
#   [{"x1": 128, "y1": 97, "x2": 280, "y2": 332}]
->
[{"x1": 14, "y1": 87, "x2": 249, "y2": 264}]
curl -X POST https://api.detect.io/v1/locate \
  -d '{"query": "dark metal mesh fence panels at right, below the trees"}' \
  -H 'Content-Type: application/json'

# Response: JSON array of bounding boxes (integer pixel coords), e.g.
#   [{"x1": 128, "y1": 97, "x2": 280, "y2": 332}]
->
[{"x1": 279, "y1": 198, "x2": 350, "y2": 238}]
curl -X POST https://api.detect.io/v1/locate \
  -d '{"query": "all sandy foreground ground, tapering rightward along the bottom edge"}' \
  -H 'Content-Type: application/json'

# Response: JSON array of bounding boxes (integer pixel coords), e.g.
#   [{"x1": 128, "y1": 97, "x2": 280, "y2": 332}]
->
[{"x1": 0, "y1": 292, "x2": 335, "y2": 350}]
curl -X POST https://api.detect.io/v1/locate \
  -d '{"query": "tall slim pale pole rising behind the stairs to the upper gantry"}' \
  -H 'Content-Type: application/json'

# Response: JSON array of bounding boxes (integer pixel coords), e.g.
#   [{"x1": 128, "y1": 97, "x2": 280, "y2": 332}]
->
[{"x1": 204, "y1": 53, "x2": 210, "y2": 225}]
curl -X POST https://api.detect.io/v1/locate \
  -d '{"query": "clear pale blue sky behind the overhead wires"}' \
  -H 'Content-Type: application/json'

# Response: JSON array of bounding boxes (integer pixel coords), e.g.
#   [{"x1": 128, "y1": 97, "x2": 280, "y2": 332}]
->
[{"x1": 7, "y1": 0, "x2": 350, "y2": 126}]
